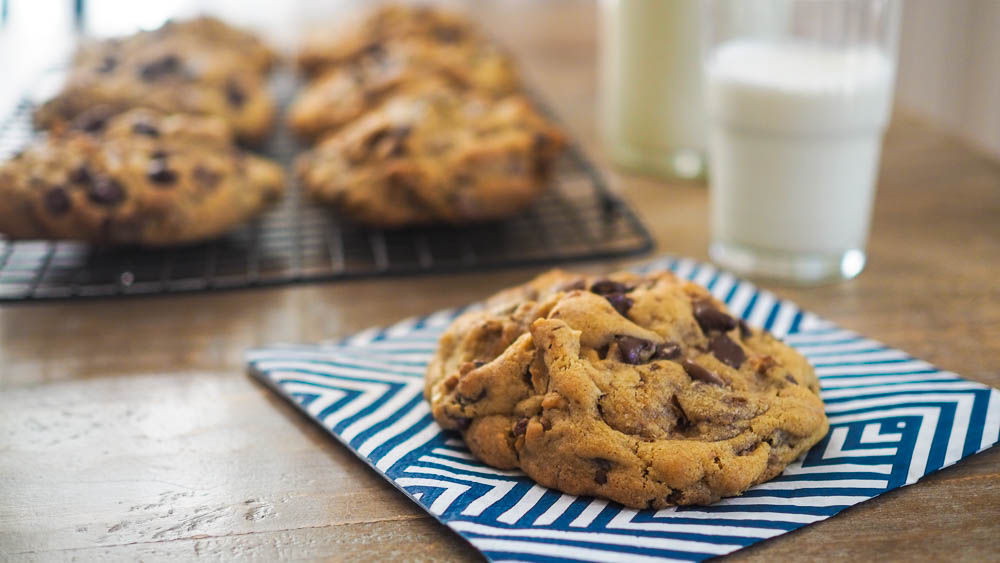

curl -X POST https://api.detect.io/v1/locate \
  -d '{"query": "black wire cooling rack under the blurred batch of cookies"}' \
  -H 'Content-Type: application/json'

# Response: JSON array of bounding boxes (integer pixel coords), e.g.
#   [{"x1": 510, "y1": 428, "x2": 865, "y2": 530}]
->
[{"x1": 0, "y1": 71, "x2": 653, "y2": 302}]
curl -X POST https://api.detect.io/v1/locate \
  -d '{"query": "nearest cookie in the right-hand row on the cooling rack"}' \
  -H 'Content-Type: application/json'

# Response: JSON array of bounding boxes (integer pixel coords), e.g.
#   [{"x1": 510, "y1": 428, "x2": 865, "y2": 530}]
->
[{"x1": 297, "y1": 80, "x2": 564, "y2": 227}]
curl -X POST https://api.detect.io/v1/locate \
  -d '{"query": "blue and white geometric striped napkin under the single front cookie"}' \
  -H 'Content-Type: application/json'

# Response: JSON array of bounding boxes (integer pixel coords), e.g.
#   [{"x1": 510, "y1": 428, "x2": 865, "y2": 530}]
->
[{"x1": 248, "y1": 259, "x2": 1000, "y2": 561}]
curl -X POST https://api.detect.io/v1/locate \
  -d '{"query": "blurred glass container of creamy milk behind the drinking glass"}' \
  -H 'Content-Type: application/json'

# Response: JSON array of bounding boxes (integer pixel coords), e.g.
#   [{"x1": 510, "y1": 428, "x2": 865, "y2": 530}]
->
[{"x1": 599, "y1": 0, "x2": 705, "y2": 179}]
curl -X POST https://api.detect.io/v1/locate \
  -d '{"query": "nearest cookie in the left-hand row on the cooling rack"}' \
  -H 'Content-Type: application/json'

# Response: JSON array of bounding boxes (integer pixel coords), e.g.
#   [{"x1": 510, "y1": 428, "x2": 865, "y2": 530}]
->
[{"x1": 0, "y1": 109, "x2": 284, "y2": 246}]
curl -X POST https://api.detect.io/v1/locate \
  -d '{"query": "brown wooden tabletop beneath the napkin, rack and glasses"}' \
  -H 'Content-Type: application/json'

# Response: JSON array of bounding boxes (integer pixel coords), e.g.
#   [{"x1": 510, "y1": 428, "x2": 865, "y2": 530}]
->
[{"x1": 0, "y1": 1, "x2": 1000, "y2": 561}]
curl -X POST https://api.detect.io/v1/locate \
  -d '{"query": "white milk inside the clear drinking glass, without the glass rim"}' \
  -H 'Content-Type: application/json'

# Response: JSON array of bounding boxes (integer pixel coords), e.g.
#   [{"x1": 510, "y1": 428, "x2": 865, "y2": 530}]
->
[{"x1": 706, "y1": 40, "x2": 895, "y2": 268}]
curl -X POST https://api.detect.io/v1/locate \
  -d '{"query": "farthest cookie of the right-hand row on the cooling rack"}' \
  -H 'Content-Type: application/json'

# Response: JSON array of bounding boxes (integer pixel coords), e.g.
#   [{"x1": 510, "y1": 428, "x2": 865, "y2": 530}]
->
[{"x1": 297, "y1": 4, "x2": 484, "y2": 75}]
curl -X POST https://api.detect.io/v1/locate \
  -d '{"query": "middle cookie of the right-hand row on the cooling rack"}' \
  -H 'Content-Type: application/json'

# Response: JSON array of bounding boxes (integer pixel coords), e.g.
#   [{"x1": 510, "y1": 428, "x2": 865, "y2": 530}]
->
[{"x1": 289, "y1": 39, "x2": 518, "y2": 139}]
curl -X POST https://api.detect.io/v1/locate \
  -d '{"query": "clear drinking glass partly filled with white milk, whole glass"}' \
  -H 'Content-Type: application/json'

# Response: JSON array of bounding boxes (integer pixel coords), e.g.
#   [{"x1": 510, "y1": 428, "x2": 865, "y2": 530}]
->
[{"x1": 702, "y1": 0, "x2": 900, "y2": 284}]
